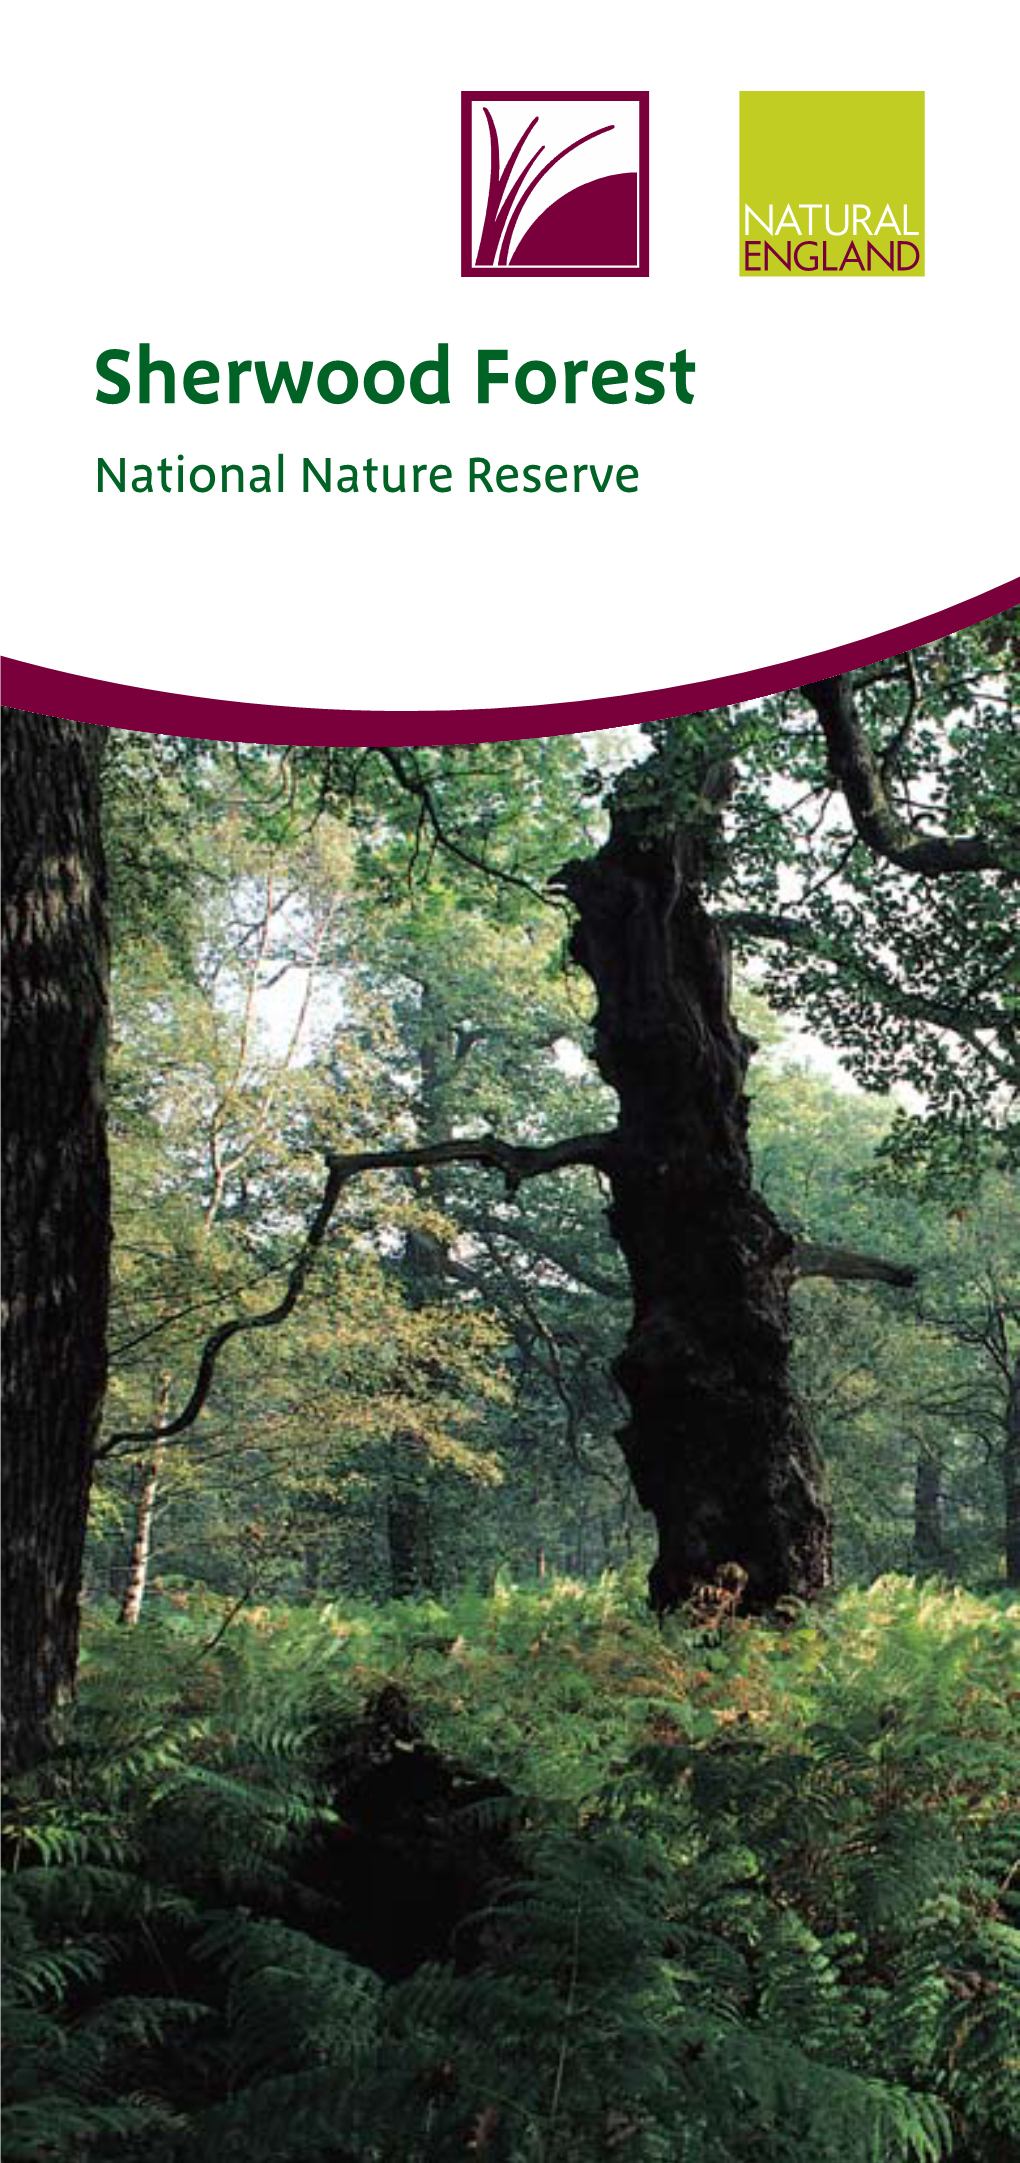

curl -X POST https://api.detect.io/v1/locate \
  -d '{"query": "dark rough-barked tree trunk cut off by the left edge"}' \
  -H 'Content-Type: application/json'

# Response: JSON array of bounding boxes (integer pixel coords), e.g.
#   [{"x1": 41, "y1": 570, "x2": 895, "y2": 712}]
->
[{"x1": 2, "y1": 709, "x2": 110, "y2": 1765}]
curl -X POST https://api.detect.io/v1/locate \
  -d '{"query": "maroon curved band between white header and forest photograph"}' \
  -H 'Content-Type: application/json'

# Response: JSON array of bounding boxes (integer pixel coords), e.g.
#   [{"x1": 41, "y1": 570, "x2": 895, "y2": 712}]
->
[{"x1": 0, "y1": 578, "x2": 1020, "y2": 746}]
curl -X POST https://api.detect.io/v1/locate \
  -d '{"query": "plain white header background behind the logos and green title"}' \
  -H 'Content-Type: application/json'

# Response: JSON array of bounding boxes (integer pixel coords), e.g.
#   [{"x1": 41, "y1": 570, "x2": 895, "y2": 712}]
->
[{"x1": 2, "y1": 0, "x2": 1018, "y2": 707}]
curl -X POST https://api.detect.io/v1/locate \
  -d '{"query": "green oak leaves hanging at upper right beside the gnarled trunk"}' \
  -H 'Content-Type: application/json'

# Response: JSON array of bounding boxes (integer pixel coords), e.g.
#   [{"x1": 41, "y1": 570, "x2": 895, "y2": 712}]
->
[{"x1": 724, "y1": 610, "x2": 1020, "y2": 1150}]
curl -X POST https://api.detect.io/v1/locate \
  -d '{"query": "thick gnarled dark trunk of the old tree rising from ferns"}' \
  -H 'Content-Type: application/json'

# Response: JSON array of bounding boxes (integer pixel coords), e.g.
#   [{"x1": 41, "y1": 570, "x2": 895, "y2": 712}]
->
[{"x1": 560, "y1": 761, "x2": 830, "y2": 1611}]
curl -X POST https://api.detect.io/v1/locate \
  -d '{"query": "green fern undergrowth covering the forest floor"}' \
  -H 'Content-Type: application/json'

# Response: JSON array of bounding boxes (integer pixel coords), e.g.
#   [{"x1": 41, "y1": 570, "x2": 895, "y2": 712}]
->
[{"x1": 4, "y1": 1579, "x2": 1020, "y2": 2163}]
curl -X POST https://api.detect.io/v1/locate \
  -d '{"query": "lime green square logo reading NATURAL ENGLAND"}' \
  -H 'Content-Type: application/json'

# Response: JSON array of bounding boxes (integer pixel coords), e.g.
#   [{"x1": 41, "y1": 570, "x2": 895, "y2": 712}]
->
[{"x1": 739, "y1": 91, "x2": 925, "y2": 277}]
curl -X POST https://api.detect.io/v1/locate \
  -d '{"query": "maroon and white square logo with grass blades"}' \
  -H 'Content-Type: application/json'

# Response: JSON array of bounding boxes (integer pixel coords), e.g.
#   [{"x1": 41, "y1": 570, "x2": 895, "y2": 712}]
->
[{"x1": 460, "y1": 91, "x2": 648, "y2": 277}]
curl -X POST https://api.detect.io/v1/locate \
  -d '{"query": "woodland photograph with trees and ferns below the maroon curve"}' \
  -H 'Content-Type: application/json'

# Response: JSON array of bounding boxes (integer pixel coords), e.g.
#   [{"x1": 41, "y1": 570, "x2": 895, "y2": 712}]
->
[{"x1": 2, "y1": 610, "x2": 1020, "y2": 2163}]
